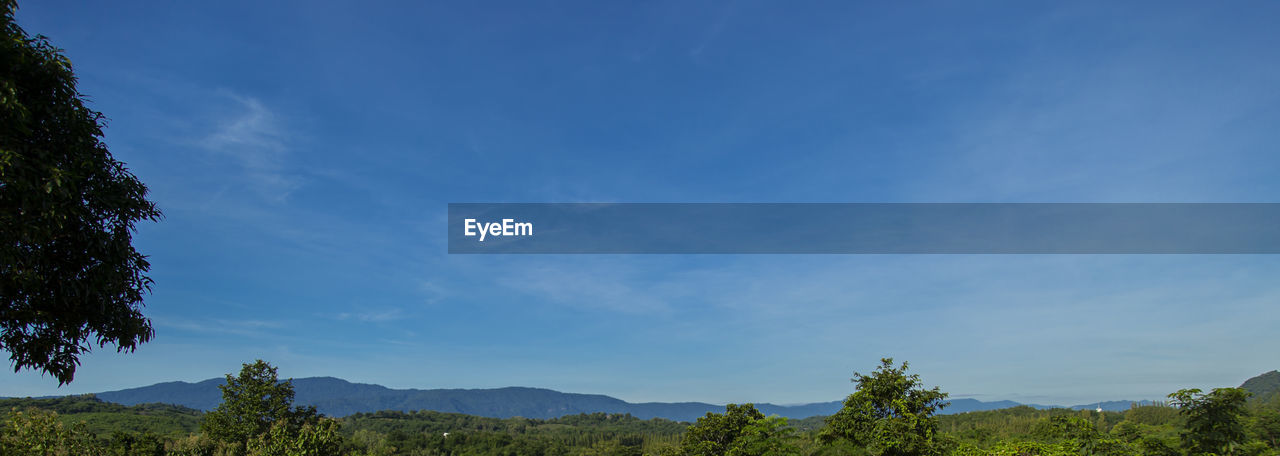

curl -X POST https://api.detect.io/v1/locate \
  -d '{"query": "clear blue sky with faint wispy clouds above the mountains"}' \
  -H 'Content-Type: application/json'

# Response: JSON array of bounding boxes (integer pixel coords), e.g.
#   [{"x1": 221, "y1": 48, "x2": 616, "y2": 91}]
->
[{"x1": 0, "y1": 1, "x2": 1280, "y2": 403}]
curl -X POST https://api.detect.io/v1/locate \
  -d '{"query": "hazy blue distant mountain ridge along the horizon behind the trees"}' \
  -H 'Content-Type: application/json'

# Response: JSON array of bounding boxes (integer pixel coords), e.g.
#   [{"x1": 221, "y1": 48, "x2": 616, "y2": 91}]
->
[{"x1": 77, "y1": 377, "x2": 1152, "y2": 421}]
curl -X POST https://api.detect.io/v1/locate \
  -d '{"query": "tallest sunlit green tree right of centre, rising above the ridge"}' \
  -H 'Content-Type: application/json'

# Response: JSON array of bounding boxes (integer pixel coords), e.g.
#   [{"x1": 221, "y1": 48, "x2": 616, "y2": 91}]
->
[{"x1": 820, "y1": 357, "x2": 948, "y2": 456}]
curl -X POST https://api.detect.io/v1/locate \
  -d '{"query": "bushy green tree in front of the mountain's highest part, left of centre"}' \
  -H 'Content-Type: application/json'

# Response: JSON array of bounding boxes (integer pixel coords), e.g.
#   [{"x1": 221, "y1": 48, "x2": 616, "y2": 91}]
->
[{"x1": 200, "y1": 360, "x2": 320, "y2": 444}]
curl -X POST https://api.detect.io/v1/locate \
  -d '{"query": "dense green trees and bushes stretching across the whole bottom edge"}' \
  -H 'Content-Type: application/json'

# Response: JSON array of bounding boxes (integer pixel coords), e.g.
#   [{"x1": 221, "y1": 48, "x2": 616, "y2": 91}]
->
[{"x1": 0, "y1": 360, "x2": 1280, "y2": 456}]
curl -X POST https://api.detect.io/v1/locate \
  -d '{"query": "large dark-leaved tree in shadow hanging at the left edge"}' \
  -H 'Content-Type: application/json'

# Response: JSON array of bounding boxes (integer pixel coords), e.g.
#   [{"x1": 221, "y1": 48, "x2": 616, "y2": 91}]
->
[{"x1": 0, "y1": 0, "x2": 160, "y2": 386}]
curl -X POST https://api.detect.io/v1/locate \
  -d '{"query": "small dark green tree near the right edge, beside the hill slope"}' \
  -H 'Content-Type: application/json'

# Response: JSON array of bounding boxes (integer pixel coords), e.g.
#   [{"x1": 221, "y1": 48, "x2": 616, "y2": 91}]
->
[{"x1": 1169, "y1": 388, "x2": 1249, "y2": 455}]
